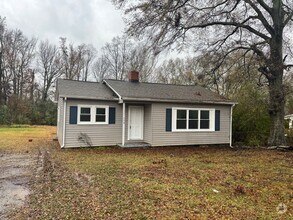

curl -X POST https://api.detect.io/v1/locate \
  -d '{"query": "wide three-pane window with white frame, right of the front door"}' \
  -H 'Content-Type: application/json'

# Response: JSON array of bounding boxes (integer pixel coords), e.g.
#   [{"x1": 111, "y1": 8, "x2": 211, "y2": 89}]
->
[{"x1": 172, "y1": 108, "x2": 215, "y2": 131}]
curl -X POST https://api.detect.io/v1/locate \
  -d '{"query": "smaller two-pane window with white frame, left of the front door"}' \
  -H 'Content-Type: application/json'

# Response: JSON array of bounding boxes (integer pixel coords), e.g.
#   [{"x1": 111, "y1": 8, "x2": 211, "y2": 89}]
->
[{"x1": 78, "y1": 105, "x2": 109, "y2": 124}]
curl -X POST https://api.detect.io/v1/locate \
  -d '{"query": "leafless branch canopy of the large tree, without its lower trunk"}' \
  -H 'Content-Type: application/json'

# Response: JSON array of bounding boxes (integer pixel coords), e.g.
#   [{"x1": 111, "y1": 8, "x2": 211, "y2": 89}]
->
[{"x1": 113, "y1": 0, "x2": 293, "y2": 77}]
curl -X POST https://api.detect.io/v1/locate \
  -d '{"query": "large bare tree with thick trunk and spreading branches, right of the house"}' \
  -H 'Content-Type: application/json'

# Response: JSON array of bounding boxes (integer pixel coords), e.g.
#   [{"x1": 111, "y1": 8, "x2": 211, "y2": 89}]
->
[{"x1": 113, "y1": 0, "x2": 293, "y2": 145}]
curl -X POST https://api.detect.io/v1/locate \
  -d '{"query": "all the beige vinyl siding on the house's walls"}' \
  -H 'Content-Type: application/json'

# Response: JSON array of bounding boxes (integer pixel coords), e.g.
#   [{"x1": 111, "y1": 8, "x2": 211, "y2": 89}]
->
[{"x1": 62, "y1": 99, "x2": 231, "y2": 147}]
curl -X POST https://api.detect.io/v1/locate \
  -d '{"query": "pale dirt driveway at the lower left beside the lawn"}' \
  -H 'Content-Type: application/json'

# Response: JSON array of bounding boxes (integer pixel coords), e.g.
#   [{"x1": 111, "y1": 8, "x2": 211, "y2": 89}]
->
[{"x1": 0, "y1": 153, "x2": 36, "y2": 220}]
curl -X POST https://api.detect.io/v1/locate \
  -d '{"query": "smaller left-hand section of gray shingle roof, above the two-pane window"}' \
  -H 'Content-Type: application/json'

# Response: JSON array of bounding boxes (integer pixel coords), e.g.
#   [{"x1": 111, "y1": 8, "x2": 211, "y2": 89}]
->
[{"x1": 57, "y1": 79, "x2": 117, "y2": 100}]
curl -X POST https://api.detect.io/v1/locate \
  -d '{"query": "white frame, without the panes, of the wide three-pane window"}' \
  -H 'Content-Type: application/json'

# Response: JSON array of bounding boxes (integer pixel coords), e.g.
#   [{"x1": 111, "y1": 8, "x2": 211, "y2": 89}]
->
[{"x1": 172, "y1": 107, "x2": 215, "y2": 132}]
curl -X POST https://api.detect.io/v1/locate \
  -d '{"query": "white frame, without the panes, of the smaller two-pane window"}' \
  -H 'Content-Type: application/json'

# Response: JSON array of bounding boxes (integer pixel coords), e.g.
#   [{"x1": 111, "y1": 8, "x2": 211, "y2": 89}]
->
[{"x1": 77, "y1": 105, "x2": 109, "y2": 124}]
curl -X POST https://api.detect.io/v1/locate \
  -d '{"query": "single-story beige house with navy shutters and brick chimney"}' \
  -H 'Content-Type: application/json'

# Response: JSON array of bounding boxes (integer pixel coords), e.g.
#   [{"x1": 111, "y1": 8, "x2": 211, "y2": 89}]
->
[{"x1": 55, "y1": 71, "x2": 235, "y2": 148}]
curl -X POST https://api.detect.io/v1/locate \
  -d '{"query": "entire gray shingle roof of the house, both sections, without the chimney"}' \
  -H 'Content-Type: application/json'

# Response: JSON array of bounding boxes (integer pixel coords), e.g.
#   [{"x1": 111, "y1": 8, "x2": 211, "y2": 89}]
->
[{"x1": 56, "y1": 79, "x2": 233, "y2": 104}]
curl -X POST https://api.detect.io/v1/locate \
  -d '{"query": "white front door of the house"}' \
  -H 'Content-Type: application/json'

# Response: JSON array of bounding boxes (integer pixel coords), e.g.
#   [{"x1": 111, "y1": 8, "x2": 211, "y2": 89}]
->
[{"x1": 128, "y1": 106, "x2": 143, "y2": 140}]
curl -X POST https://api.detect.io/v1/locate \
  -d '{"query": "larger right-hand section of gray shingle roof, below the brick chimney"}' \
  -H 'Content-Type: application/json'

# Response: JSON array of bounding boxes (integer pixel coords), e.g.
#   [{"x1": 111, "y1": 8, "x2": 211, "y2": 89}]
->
[{"x1": 104, "y1": 80, "x2": 233, "y2": 104}]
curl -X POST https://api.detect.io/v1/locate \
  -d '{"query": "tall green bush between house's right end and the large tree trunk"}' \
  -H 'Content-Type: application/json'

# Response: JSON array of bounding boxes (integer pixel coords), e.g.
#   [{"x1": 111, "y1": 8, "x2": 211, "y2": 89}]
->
[{"x1": 233, "y1": 84, "x2": 271, "y2": 146}]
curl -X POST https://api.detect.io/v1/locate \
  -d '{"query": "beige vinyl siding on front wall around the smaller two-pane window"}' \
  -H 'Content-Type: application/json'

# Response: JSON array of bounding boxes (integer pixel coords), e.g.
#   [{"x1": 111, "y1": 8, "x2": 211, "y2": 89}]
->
[{"x1": 65, "y1": 99, "x2": 122, "y2": 147}]
